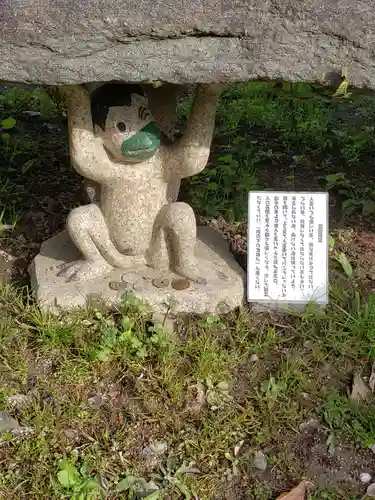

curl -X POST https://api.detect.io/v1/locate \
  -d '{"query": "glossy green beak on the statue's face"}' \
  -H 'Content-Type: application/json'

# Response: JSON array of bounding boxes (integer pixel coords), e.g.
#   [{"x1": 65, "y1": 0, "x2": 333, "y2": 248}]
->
[{"x1": 121, "y1": 122, "x2": 160, "y2": 161}]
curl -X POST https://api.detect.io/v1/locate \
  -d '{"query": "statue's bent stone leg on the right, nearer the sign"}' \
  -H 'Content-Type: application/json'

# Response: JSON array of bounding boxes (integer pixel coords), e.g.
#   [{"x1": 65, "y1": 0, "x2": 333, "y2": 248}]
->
[{"x1": 151, "y1": 202, "x2": 206, "y2": 283}]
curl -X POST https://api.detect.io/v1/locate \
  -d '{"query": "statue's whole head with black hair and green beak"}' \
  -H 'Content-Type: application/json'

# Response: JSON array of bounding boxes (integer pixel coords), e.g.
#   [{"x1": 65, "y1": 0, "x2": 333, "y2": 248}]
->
[{"x1": 91, "y1": 83, "x2": 160, "y2": 163}]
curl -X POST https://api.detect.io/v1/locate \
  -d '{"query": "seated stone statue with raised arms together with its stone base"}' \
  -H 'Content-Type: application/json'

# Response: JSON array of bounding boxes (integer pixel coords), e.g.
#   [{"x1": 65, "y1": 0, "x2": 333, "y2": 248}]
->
[{"x1": 30, "y1": 84, "x2": 244, "y2": 313}]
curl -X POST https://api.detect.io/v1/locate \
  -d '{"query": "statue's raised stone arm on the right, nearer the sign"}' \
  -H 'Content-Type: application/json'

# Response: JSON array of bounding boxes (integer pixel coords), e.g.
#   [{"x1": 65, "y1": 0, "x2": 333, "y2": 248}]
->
[{"x1": 167, "y1": 84, "x2": 222, "y2": 178}]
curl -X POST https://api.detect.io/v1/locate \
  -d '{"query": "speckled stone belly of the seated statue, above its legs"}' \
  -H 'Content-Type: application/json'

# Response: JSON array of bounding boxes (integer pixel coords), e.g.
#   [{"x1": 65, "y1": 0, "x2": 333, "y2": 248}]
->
[{"x1": 101, "y1": 185, "x2": 167, "y2": 255}]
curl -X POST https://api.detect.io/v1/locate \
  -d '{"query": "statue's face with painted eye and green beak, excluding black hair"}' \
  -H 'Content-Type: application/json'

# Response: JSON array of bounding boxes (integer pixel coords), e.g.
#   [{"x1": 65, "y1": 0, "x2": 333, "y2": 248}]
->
[{"x1": 96, "y1": 94, "x2": 160, "y2": 163}]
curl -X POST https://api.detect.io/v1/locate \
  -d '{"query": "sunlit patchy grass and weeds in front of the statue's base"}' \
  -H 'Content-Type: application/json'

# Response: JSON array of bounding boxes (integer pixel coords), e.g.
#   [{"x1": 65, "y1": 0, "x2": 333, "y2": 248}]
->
[{"x1": 0, "y1": 287, "x2": 375, "y2": 499}]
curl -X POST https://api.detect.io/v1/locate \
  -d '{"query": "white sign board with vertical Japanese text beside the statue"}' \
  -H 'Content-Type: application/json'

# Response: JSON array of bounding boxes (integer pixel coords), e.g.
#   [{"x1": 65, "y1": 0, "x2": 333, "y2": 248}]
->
[{"x1": 247, "y1": 191, "x2": 328, "y2": 307}]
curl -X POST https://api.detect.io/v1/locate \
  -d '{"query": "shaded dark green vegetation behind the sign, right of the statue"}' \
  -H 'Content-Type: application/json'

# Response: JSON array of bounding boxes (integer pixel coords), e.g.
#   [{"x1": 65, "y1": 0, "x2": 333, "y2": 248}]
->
[{"x1": 180, "y1": 82, "x2": 375, "y2": 221}]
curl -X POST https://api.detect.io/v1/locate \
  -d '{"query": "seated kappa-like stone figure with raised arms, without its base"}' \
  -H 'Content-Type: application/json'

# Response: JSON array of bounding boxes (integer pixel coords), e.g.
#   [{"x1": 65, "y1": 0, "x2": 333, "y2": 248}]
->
[{"x1": 60, "y1": 83, "x2": 221, "y2": 284}]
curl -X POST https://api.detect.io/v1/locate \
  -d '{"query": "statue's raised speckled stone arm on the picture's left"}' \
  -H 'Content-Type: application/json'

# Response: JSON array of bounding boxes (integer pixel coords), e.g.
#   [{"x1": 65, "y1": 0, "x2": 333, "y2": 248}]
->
[{"x1": 61, "y1": 85, "x2": 115, "y2": 183}]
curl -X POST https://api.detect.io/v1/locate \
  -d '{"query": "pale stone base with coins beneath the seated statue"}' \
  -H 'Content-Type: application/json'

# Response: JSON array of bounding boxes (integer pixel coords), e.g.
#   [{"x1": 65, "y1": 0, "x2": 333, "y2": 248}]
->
[{"x1": 29, "y1": 227, "x2": 245, "y2": 314}]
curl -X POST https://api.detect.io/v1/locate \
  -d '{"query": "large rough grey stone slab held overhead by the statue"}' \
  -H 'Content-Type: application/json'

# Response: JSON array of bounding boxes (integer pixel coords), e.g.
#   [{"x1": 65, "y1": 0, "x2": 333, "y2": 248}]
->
[{"x1": 0, "y1": 0, "x2": 375, "y2": 88}]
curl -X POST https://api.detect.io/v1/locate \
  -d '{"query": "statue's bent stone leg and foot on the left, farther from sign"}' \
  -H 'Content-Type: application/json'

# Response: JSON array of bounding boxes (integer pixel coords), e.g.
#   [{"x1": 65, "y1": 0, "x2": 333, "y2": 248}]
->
[{"x1": 60, "y1": 204, "x2": 139, "y2": 280}]
